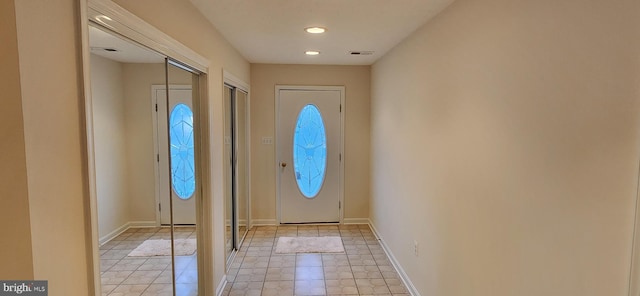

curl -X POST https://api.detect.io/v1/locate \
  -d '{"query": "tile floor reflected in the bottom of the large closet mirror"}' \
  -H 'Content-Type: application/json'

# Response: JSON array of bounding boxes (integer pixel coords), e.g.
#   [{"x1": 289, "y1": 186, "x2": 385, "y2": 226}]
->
[{"x1": 100, "y1": 227, "x2": 198, "y2": 296}]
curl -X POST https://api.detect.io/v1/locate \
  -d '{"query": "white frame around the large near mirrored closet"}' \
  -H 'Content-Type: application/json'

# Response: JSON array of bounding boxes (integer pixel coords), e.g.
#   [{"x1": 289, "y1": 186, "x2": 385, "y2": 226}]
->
[{"x1": 79, "y1": 0, "x2": 210, "y2": 295}]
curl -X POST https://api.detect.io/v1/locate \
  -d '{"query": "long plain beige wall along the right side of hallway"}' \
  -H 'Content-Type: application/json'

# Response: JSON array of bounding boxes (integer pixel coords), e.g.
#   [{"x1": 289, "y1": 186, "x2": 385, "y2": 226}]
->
[{"x1": 371, "y1": 0, "x2": 640, "y2": 296}]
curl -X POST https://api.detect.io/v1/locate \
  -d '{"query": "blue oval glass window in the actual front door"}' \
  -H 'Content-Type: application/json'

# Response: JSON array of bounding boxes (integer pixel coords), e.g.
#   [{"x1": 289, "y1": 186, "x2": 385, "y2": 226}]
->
[{"x1": 293, "y1": 105, "x2": 327, "y2": 198}]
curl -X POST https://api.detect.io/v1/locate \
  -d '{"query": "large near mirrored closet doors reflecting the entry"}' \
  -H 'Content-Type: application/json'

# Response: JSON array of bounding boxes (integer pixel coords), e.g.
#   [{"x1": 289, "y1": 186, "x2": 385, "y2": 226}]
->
[{"x1": 89, "y1": 22, "x2": 202, "y2": 296}]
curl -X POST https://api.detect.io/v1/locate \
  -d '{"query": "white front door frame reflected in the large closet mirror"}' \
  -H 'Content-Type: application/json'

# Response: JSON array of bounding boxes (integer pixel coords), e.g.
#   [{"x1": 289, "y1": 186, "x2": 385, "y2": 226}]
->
[{"x1": 149, "y1": 84, "x2": 197, "y2": 227}]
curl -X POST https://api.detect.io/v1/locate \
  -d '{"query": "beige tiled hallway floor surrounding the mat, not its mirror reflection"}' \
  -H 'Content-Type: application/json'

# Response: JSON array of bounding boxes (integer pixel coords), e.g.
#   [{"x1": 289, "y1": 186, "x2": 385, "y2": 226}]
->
[{"x1": 223, "y1": 225, "x2": 409, "y2": 296}]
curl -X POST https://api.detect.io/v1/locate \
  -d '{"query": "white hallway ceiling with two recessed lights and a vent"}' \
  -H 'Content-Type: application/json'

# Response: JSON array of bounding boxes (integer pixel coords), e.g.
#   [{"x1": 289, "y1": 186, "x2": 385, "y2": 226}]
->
[{"x1": 191, "y1": 0, "x2": 454, "y2": 65}]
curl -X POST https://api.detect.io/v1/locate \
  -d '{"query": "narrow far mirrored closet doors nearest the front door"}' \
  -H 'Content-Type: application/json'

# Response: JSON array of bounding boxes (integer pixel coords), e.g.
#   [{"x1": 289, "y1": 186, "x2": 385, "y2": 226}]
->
[{"x1": 224, "y1": 84, "x2": 249, "y2": 263}]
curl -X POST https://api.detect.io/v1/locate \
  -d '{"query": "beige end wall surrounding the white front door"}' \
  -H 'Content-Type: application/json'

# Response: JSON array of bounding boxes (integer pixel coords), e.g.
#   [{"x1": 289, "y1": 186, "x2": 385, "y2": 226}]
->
[{"x1": 251, "y1": 64, "x2": 370, "y2": 222}]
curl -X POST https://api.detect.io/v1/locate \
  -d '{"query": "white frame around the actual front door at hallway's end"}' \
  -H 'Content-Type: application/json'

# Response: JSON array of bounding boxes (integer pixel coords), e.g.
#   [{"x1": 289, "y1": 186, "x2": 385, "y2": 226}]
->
[{"x1": 273, "y1": 85, "x2": 347, "y2": 224}]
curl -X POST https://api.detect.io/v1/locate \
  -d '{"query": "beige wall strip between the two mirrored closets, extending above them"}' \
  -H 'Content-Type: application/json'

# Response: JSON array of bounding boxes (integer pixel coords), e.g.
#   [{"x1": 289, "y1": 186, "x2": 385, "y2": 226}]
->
[{"x1": 114, "y1": 0, "x2": 250, "y2": 287}]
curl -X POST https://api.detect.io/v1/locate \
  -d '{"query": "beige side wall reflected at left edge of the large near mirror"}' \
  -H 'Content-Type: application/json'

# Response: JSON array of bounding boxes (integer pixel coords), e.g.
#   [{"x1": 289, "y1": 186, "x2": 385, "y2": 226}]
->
[{"x1": 91, "y1": 54, "x2": 129, "y2": 238}]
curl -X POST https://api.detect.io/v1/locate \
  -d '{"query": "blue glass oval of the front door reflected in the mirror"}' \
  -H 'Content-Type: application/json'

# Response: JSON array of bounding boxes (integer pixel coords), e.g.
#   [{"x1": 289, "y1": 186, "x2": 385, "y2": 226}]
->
[{"x1": 169, "y1": 104, "x2": 196, "y2": 199}]
